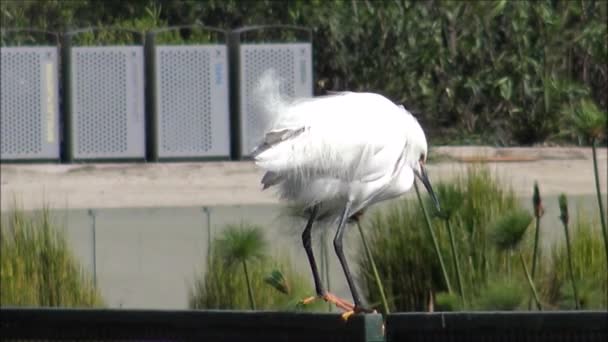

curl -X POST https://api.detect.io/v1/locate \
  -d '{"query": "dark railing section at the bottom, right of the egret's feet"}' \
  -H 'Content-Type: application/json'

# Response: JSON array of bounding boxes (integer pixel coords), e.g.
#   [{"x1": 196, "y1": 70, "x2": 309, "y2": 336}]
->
[{"x1": 386, "y1": 311, "x2": 608, "y2": 342}]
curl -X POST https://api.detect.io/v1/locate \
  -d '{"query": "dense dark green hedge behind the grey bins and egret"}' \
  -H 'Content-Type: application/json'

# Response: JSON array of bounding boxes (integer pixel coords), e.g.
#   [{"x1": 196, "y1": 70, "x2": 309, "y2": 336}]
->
[{"x1": 0, "y1": 0, "x2": 608, "y2": 144}]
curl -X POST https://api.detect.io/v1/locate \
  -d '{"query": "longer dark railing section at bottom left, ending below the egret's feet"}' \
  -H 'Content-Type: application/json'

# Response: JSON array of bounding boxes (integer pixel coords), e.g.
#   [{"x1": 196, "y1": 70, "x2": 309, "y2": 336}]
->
[{"x1": 0, "y1": 308, "x2": 384, "y2": 342}]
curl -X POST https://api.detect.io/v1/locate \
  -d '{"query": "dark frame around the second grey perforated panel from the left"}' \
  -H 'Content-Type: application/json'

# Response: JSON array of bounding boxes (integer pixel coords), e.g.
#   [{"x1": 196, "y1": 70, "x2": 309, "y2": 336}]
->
[{"x1": 63, "y1": 27, "x2": 146, "y2": 162}]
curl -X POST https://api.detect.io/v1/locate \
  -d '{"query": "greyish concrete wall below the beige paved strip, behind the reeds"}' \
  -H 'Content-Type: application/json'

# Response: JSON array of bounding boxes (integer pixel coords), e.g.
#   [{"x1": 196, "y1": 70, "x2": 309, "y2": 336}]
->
[{"x1": 7, "y1": 194, "x2": 597, "y2": 309}]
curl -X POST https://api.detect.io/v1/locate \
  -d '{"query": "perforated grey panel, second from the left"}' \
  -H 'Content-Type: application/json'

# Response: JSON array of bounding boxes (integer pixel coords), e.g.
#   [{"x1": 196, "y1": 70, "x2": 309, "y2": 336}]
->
[{"x1": 70, "y1": 46, "x2": 145, "y2": 160}]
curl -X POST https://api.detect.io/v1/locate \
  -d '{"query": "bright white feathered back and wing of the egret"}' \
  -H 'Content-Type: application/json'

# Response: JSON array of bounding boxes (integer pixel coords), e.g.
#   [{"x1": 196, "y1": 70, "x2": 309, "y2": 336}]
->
[{"x1": 253, "y1": 93, "x2": 409, "y2": 185}]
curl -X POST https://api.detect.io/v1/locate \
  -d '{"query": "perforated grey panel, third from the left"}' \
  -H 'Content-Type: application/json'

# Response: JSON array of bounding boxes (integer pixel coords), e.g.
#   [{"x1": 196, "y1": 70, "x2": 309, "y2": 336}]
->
[{"x1": 154, "y1": 45, "x2": 230, "y2": 158}]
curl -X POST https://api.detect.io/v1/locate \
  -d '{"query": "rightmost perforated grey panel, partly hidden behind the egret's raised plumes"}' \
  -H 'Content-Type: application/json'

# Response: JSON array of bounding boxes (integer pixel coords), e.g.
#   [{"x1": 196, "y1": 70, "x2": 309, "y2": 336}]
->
[{"x1": 239, "y1": 43, "x2": 313, "y2": 156}]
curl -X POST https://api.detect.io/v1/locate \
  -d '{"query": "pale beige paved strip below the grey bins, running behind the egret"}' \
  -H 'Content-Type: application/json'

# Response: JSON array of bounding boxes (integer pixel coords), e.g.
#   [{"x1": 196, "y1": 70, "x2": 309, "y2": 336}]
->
[{"x1": 1, "y1": 147, "x2": 607, "y2": 210}]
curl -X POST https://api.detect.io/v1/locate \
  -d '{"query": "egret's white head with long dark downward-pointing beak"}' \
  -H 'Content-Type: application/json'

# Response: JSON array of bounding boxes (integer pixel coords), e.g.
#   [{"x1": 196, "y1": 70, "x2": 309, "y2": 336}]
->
[{"x1": 406, "y1": 114, "x2": 441, "y2": 212}]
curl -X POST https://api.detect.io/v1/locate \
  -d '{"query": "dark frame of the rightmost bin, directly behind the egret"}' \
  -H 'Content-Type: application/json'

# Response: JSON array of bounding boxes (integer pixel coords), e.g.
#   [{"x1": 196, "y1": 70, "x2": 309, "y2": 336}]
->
[{"x1": 229, "y1": 25, "x2": 314, "y2": 159}]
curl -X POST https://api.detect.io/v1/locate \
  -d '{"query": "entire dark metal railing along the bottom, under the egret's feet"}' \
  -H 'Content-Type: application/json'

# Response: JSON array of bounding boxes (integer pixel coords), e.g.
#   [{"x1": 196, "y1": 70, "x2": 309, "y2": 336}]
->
[{"x1": 0, "y1": 308, "x2": 608, "y2": 342}]
